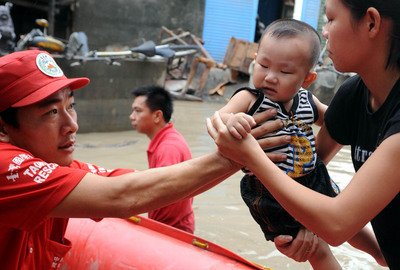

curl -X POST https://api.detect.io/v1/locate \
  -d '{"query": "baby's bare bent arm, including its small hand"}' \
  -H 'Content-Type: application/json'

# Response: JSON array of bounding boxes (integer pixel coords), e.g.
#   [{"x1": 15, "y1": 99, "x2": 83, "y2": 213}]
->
[{"x1": 214, "y1": 90, "x2": 256, "y2": 139}]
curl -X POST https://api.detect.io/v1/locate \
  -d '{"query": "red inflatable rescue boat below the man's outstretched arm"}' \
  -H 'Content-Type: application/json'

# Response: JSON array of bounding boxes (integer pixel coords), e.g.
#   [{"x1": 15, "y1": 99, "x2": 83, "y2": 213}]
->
[{"x1": 60, "y1": 216, "x2": 270, "y2": 270}]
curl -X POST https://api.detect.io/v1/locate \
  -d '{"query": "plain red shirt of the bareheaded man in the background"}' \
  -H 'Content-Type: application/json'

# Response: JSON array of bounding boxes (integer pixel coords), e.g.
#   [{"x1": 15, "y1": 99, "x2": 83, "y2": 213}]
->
[{"x1": 147, "y1": 123, "x2": 194, "y2": 233}]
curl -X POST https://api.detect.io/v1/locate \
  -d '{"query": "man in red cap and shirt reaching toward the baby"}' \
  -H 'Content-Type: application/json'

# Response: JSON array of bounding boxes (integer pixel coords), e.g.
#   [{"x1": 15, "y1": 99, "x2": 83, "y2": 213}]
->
[{"x1": 0, "y1": 50, "x2": 282, "y2": 269}]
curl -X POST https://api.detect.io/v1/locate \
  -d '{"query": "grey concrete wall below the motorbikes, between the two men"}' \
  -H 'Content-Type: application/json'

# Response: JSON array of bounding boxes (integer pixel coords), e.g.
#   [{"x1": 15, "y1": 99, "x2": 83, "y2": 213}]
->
[{"x1": 56, "y1": 58, "x2": 167, "y2": 133}]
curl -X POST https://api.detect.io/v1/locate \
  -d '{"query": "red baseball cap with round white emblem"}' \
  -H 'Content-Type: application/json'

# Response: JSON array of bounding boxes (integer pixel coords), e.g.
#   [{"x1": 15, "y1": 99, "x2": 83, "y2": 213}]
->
[{"x1": 0, "y1": 50, "x2": 89, "y2": 112}]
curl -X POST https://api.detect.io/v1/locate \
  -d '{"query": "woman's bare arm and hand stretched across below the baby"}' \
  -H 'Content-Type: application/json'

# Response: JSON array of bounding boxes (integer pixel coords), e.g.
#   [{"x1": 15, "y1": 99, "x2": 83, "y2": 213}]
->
[{"x1": 208, "y1": 110, "x2": 400, "y2": 245}]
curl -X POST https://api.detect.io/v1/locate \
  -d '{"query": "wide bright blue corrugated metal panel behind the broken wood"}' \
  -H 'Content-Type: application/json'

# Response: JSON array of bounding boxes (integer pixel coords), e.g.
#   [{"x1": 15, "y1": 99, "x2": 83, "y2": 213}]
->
[{"x1": 203, "y1": 0, "x2": 258, "y2": 63}]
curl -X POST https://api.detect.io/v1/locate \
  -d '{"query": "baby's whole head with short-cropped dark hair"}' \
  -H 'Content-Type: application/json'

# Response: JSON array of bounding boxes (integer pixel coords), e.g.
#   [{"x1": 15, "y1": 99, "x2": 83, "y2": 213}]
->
[{"x1": 253, "y1": 19, "x2": 321, "y2": 102}]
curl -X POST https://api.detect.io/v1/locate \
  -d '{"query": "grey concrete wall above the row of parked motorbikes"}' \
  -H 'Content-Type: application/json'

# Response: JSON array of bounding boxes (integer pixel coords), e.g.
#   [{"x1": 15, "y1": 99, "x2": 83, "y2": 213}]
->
[{"x1": 72, "y1": 0, "x2": 205, "y2": 50}]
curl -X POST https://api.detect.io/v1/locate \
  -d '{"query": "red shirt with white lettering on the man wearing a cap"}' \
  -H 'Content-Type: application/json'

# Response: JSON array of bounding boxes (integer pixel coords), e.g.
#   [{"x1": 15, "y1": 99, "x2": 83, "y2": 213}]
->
[{"x1": 0, "y1": 143, "x2": 131, "y2": 270}]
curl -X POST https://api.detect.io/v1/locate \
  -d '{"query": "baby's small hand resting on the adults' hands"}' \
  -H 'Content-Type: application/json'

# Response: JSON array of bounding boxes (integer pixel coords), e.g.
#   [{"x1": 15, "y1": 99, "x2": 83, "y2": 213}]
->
[{"x1": 226, "y1": 112, "x2": 256, "y2": 140}]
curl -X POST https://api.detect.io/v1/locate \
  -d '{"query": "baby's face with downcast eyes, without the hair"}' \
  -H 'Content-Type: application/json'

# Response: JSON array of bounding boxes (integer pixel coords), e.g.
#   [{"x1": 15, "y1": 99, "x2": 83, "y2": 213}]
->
[{"x1": 253, "y1": 34, "x2": 311, "y2": 102}]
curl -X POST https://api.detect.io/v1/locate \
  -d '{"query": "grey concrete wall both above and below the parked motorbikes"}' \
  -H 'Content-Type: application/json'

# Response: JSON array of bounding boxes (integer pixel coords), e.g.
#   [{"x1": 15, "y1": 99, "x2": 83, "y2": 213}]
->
[{"x1": 65, "y1": 0, "x2": 204, "y2": 132}]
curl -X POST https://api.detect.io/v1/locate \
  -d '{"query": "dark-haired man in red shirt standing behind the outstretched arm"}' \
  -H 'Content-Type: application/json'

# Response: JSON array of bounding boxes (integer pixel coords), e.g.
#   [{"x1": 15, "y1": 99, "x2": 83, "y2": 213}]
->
[{"x1": 129, "y1": 86, "x2": 194, "y2": 233}]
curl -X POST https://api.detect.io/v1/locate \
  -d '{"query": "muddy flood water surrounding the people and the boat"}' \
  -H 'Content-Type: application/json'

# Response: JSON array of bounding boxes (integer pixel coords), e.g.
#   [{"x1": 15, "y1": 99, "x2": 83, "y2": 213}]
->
[{"x1": 76, "y1": 101, "x2": 386, "y2": 270}]
